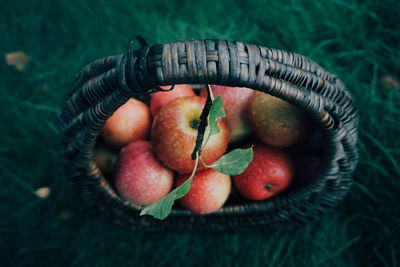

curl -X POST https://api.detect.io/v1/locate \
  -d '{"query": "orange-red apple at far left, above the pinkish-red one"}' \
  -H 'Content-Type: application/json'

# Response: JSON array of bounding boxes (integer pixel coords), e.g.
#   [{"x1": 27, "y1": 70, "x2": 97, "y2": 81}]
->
[{"x1": 101, "y1": 98, "x2": 151, "y2": 148}]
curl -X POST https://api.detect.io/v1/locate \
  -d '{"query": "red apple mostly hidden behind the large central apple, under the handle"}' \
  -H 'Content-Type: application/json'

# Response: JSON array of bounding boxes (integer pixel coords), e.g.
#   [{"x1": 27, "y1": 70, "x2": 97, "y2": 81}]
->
[{"x1": 150, "y1": 84, "x2": 195, "y2": 118}]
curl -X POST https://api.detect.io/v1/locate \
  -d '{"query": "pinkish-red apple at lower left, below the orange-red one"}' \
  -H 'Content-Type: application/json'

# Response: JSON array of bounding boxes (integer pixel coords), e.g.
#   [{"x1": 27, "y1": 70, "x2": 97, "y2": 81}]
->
[{"x1": 114, "y1": 140, "x2": 174, "y2": 205}]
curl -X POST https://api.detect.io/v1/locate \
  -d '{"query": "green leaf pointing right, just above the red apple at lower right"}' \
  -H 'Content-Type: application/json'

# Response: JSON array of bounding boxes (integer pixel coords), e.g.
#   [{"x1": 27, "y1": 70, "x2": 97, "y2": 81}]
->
[{"x1": 210, "y1": 147, "x2": 253, "y2": 175}]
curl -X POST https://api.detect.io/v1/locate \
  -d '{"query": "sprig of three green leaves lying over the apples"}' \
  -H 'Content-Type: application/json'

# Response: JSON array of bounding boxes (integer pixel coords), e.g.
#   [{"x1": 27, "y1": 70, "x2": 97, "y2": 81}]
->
[{"x1": 140, "y1": 97, "x2": 253, "y2": 220}]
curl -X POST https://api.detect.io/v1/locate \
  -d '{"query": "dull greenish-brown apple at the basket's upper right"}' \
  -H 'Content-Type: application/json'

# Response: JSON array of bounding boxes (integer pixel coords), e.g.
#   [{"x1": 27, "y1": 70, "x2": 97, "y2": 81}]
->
[{"x1": 247, "y1": 92, "x2": 312, "y2": 147}]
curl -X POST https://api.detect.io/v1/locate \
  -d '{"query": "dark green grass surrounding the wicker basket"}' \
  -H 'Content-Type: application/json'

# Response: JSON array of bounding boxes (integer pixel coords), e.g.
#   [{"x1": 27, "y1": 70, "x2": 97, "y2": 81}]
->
[{"x1": 0, "y1": 0, "x2": 400, "y2": 266}]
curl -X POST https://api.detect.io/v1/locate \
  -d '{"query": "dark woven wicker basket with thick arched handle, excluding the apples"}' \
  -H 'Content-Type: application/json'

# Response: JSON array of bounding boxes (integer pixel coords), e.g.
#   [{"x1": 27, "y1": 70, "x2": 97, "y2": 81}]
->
[{"x1": 60, "y1": 38, "x2": 358, "y2": 230}]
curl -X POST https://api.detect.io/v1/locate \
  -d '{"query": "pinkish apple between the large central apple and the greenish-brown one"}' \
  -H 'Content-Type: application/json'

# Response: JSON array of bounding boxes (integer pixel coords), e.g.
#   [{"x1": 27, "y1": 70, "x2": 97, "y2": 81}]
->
[{"x1": 200, "y1": 85, "x2": 254, "y2": 142}]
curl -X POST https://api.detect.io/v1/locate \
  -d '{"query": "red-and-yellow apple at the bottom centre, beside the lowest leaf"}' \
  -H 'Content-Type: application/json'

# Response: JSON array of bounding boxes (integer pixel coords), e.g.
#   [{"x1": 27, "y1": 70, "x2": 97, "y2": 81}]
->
[{"x1": 175, "y1": 169, "x2": 231, "y2": 214}]
